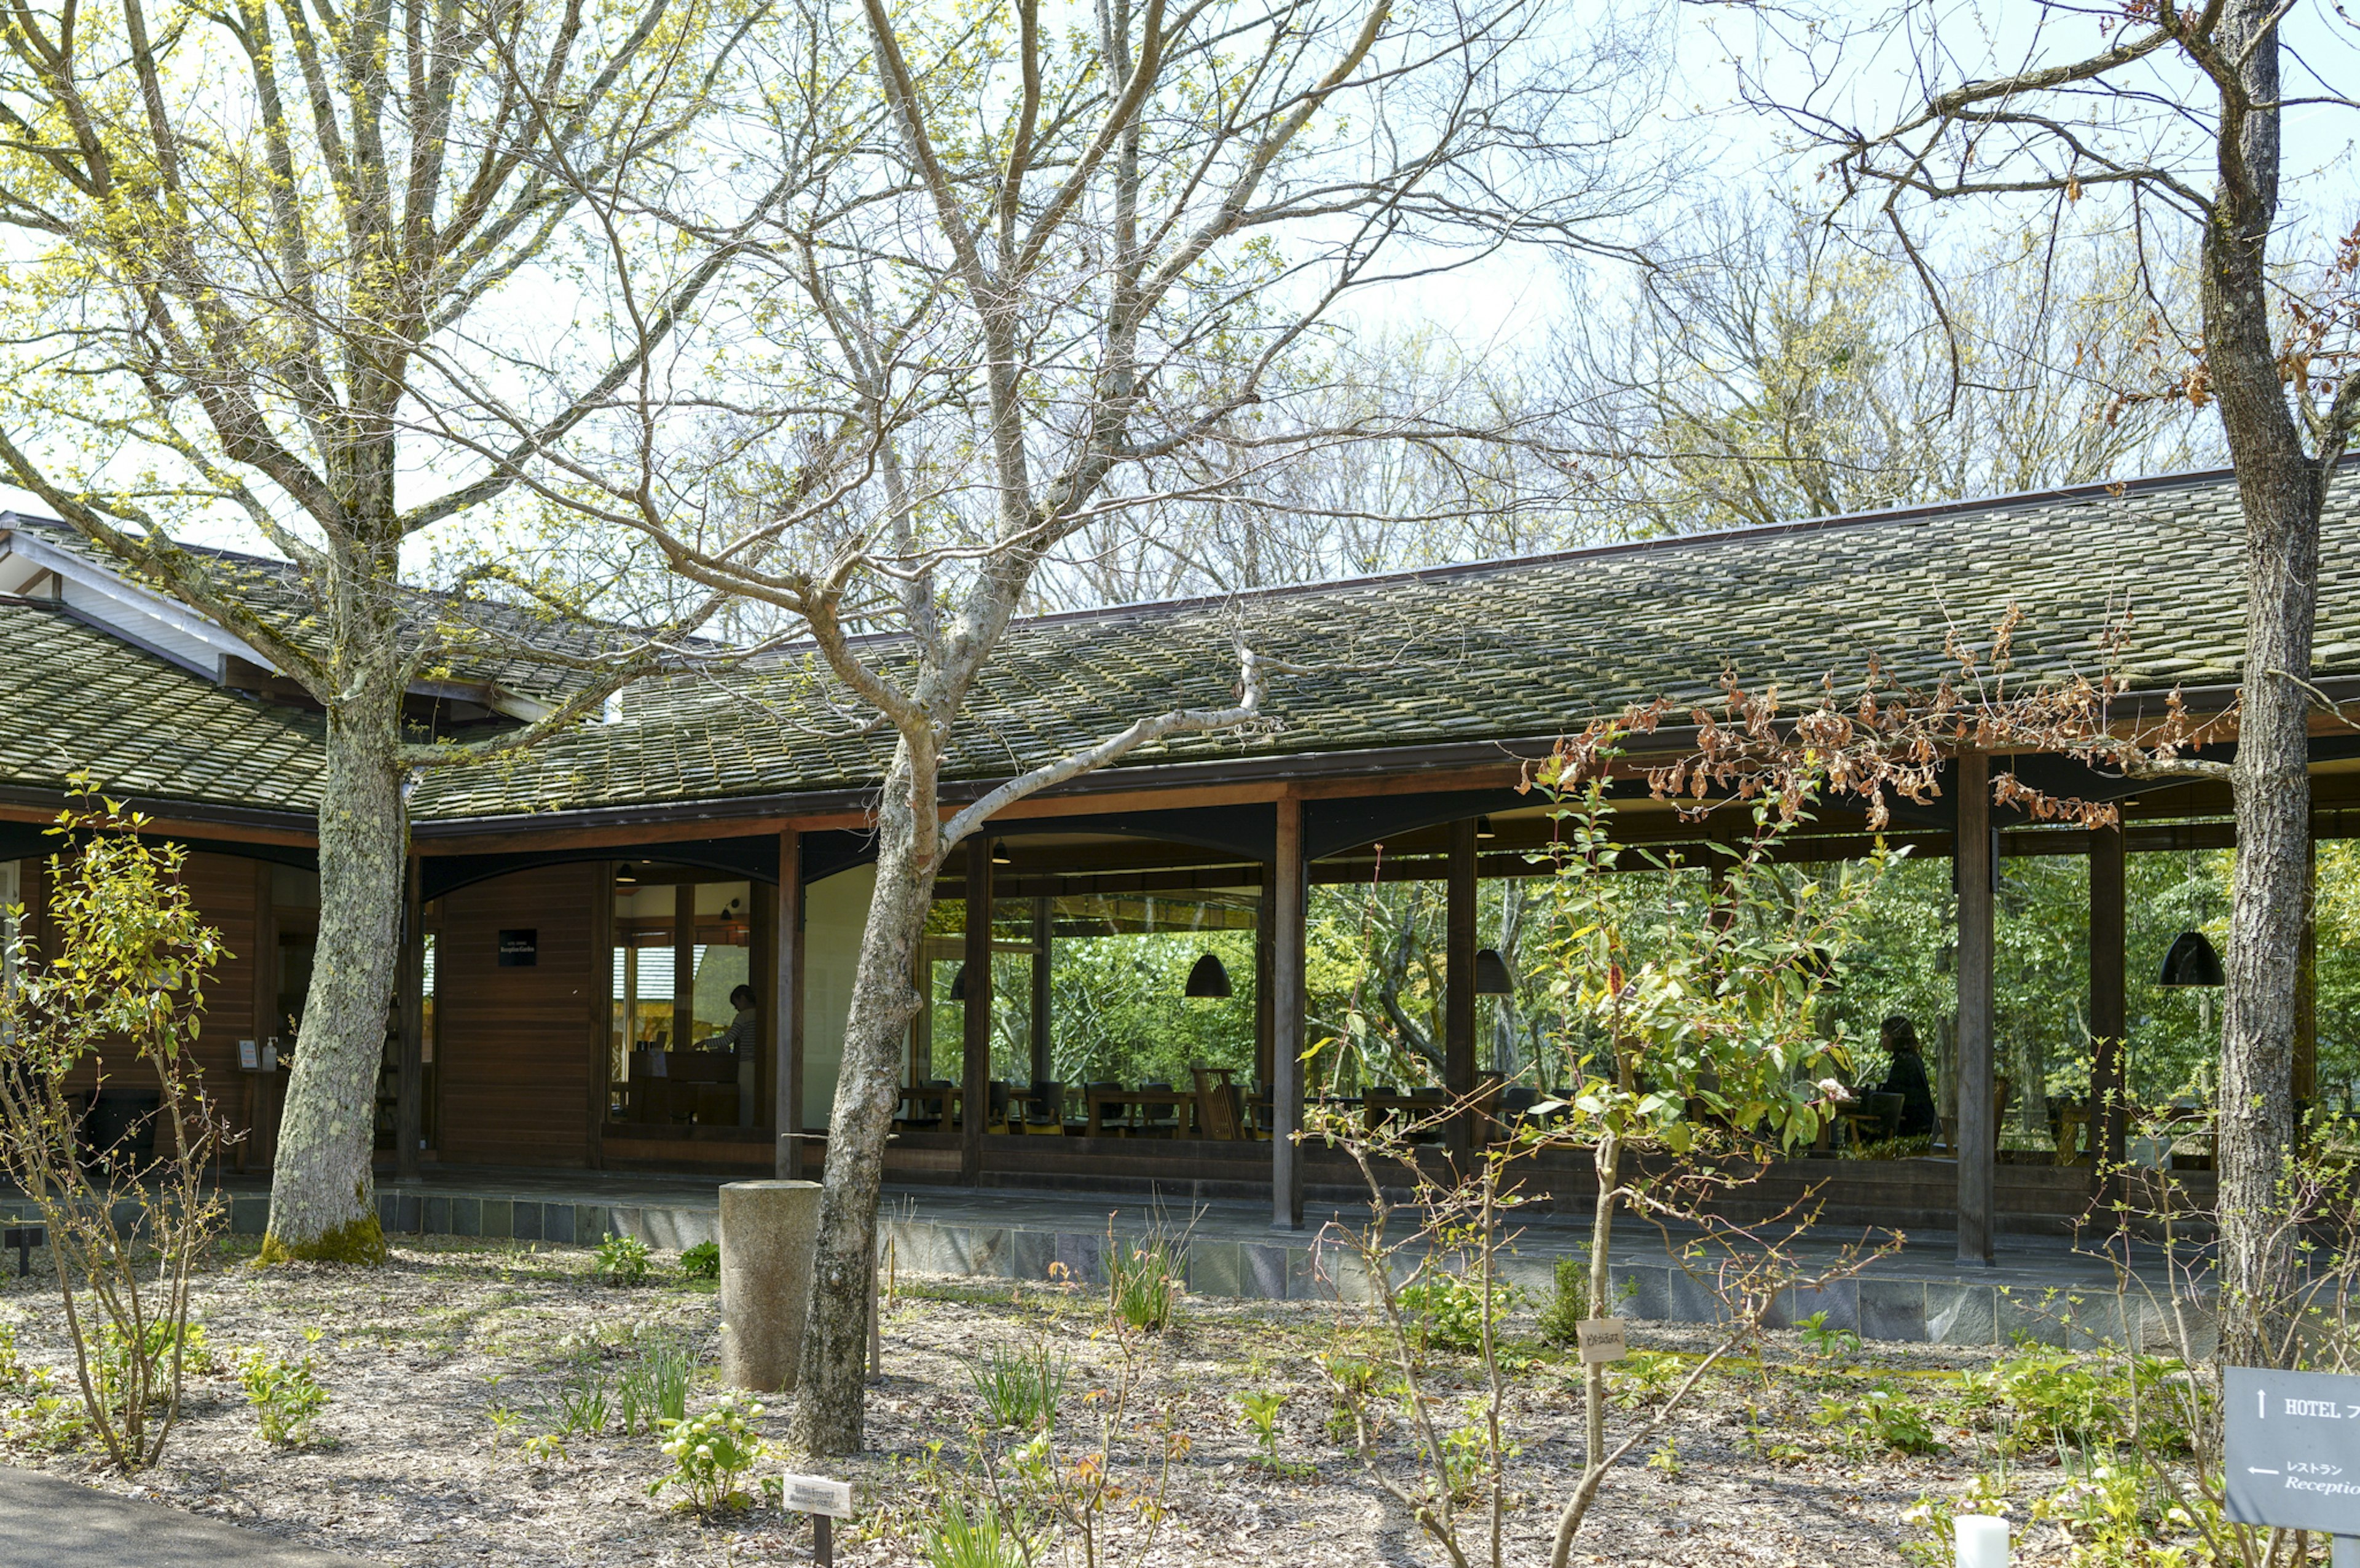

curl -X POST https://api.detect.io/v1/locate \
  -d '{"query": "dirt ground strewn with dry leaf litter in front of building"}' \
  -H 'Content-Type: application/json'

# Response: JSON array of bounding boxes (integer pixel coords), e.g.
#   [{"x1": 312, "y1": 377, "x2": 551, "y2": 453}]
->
[{"x1": 0, "y1": 1241, "x2": 2124, "y2": 1568}]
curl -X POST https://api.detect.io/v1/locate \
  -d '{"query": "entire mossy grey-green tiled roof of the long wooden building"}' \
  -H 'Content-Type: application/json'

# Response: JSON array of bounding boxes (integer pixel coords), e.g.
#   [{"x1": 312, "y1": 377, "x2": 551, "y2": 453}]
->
[{"x1": 0, "y1": 474, "x2": 2360, "y2": 818}]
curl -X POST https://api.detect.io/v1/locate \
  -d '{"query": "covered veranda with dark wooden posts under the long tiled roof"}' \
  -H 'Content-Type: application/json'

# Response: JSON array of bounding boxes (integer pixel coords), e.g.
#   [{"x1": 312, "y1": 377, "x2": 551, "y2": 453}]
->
[{"x1": 404, "y1": 716, "x2": 2360, "y2": 1261}]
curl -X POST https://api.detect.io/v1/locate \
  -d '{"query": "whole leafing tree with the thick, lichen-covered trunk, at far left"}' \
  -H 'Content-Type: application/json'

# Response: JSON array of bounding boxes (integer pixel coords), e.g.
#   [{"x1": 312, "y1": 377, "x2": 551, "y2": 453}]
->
[{"x1": 0, "y1": 0, "x2": 750, "y2": 1259}]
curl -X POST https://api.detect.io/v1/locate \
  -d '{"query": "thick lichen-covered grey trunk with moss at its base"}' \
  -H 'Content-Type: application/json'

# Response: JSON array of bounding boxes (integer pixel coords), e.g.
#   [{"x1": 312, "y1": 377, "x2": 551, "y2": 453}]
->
[{"x1": 262, "y1": 679, "x2": 408, "y2": 1264}]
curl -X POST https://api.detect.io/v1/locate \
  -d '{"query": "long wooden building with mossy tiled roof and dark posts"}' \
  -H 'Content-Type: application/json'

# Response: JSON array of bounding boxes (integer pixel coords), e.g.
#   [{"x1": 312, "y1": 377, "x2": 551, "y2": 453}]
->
[{"x1": 0, "y1": 474, "x2": 2360, "y2": 1255}]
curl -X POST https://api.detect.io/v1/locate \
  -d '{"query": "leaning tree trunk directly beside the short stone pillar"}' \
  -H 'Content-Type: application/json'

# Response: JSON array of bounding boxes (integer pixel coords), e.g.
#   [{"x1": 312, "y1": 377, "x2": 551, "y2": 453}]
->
[{"x1": 793, "y1": 748, "x2": 934, "y2": 1455}]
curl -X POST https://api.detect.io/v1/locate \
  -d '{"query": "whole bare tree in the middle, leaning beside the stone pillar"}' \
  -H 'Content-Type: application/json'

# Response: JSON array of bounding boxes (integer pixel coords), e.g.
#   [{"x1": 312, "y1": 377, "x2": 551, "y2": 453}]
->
[{"x1": 609, "y1": 0, "x2": 1657, "y2": 1452}]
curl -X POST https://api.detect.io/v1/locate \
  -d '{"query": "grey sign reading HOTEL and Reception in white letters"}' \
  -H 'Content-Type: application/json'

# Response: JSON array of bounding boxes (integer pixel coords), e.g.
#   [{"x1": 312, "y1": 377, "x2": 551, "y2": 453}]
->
[{"x1": 2220, "y1": 1368, "x2": 2360, "y2": 1535}]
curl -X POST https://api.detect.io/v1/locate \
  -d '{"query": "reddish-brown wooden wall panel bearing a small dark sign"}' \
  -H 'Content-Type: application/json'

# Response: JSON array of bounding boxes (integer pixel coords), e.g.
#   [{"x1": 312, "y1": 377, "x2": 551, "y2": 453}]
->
[{"x1": 435, "y1": 861, "x2": 613, "y2": 1167}]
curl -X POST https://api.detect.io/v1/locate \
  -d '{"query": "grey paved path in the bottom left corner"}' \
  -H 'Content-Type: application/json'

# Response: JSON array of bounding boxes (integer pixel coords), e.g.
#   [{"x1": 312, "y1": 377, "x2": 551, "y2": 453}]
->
[{"x1": 0, "y1": 1467, "x2": 368, "y2": 1568}]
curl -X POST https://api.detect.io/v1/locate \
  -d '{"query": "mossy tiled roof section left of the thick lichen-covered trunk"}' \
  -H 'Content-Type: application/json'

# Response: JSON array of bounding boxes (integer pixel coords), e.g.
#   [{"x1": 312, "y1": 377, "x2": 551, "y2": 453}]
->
[{"x1": 0, "y1": 599, "x2": 321, "y2": 811}]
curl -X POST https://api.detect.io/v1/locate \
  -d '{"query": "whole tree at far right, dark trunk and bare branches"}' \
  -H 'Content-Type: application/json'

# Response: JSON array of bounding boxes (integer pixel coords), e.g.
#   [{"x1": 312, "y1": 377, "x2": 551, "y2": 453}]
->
[{"x1": 1758, "y1": 0, "x2": 2360, "y2": 1365}]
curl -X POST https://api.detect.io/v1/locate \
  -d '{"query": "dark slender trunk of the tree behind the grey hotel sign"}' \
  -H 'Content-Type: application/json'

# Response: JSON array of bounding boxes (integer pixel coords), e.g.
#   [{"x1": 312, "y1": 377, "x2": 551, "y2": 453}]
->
[{"x1": 2202, "y1": 0, "x2": 2327, "y2": 1365}]
